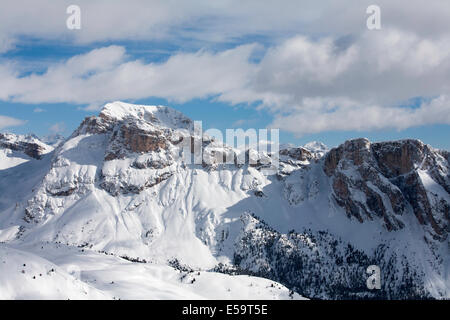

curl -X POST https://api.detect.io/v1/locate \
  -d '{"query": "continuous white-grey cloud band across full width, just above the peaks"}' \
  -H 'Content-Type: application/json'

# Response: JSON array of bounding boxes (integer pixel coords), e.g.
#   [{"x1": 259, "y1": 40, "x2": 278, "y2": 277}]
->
[{"x1": 0, "y1": 29, "x2": 450, "y2": 134}]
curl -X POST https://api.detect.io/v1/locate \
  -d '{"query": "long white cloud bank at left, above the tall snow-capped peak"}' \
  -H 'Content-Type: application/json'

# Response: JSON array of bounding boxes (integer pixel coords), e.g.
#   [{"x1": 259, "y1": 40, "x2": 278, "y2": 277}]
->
[{"x1": 0, "y1": 45, "x2": 255, "y2": 109}]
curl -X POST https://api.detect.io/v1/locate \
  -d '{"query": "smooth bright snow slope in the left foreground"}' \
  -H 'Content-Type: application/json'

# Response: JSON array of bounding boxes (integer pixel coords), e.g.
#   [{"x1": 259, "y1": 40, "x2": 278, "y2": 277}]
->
[{"x1": 0, "y1": 244, "x2": 302, "y2": 300}]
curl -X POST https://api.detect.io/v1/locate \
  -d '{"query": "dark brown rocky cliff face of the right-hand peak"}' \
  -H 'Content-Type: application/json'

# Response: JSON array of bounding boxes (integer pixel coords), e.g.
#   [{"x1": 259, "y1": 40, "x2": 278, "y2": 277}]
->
[{"x1": 324, "y1": 139, "x2": 450, "y2": 240}]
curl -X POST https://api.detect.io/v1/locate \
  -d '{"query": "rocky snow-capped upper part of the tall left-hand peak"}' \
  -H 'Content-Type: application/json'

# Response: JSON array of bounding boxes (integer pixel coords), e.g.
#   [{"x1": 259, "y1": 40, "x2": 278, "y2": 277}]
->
[{"x1": 25, "y1": 103, "x2": 192, "y2": 222}]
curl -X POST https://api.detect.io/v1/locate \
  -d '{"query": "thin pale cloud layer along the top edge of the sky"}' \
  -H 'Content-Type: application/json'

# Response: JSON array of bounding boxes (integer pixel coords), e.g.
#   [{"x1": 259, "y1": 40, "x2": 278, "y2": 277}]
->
[{"x1": 0, "y1": 0, "x2": 450, "y2": 50}]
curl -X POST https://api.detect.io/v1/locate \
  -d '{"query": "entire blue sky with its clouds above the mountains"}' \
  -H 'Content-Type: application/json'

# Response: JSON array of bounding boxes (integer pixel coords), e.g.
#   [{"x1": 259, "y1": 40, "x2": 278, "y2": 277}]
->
[{"x1": 0, "y1": 0, "x2": 450, "y2": 150}]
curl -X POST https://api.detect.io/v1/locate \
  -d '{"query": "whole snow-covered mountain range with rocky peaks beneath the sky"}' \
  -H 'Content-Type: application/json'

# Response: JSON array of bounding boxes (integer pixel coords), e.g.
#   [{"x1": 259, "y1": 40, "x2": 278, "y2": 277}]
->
[{"x1": 0, "y1": 102, "x2": 450, "y2": 299}]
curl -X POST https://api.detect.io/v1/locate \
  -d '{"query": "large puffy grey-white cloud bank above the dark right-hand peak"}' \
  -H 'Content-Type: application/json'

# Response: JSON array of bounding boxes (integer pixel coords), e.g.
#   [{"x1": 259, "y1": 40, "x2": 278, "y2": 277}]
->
[{"x1": 227, "y1": 29, "x2": 450, "y2": 135}]
